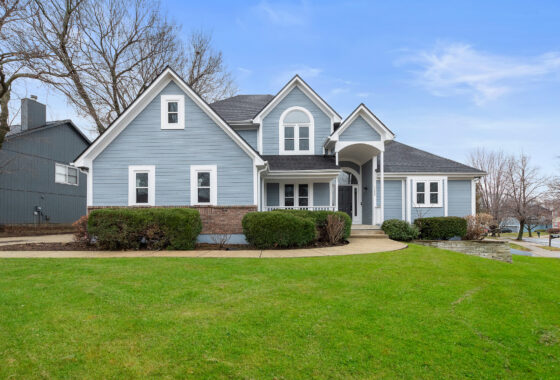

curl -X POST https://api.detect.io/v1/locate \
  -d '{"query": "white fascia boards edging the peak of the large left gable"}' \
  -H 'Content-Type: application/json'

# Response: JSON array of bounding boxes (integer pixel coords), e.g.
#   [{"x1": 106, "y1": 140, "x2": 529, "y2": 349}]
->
[{"x1": 75, "y1": 68, "x2": 264, "y2": 167}]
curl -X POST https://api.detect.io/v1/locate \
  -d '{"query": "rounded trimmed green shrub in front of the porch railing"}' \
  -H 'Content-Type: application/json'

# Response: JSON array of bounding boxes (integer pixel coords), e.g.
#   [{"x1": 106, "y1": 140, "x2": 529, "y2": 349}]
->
[{"x1": 242, "y1": 211, "x2": 316, "y2": 249}]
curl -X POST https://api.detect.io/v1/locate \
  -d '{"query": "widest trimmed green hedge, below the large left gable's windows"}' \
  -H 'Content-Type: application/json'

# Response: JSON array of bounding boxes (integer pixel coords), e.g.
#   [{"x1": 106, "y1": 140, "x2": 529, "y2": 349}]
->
[{"x1": 88, "y1": 208, "x2": 202, "y2": 250}]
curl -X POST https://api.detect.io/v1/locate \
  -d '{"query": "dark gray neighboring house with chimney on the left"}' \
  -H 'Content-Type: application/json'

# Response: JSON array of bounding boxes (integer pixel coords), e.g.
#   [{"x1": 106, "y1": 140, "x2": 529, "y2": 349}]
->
[{"x1": 0, "y1": 97, "x2": 90, "y2": 224}]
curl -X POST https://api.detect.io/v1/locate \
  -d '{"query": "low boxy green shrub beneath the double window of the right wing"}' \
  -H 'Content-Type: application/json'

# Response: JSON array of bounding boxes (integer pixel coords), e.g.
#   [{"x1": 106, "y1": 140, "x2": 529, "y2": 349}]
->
[{"x1": 414, "y1": 216, "x2": 467, "y2": 240}]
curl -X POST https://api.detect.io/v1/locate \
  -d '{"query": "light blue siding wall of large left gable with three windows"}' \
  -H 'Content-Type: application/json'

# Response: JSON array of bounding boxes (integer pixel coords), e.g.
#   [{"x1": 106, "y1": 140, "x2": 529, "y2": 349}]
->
[{"x1": 91, "y1": 81, "x2": 255, "y2": 206}]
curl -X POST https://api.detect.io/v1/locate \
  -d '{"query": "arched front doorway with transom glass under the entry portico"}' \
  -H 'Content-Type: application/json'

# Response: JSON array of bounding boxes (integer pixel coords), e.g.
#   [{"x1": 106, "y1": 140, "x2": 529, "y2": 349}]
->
[{"x1": 338, "y1": 167, "x2": 362, "y2": 224}]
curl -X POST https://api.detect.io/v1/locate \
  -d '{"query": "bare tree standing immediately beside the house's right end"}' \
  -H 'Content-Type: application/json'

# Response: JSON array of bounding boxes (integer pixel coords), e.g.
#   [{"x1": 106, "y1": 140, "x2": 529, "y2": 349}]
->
[{"x1": 469, "y1": 148, "x2": 507, "y2": 223}]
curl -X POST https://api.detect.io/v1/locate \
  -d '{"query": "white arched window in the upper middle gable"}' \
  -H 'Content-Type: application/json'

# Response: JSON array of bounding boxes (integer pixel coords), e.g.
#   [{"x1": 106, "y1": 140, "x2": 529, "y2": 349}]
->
[{"x1": 279, "y1": 107, "x2": 314, "y2": 154}]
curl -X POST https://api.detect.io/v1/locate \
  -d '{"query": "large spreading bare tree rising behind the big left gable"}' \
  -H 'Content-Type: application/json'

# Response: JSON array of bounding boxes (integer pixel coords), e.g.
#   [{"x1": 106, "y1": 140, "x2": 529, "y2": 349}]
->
[{"x1": 25, "y1": 0, "x2": 235, "y2": 133}]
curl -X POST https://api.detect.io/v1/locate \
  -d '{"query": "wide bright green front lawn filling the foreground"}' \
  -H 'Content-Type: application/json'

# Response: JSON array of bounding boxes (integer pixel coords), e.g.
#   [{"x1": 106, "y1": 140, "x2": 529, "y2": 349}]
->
[{"x1": 0, "y1": 245, "x2": 560, "y2": 379}]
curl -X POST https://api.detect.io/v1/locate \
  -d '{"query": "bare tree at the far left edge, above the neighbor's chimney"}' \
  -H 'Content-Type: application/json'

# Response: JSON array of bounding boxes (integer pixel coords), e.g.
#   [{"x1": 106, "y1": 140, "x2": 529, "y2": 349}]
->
[{"x1": 0, "y1": 0, "x2": 44, "y2": 148}]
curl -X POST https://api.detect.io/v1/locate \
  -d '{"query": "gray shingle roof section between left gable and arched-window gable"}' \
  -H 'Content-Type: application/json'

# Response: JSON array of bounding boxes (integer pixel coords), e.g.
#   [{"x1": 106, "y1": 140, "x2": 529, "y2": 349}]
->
[{"x1": 210, "y1": 95, "x2": 274, "y2": 122}]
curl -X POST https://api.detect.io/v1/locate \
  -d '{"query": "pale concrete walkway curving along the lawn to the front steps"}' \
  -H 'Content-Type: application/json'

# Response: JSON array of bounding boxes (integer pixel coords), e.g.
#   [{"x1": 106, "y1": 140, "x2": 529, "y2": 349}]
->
[{"x1": 0, "y1": 238, "x2": 407, "y2": 258}]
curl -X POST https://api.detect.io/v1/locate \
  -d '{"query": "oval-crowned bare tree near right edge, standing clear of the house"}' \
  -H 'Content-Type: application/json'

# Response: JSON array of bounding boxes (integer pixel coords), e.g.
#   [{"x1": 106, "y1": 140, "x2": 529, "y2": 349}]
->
[{"x1": 505, "y1": 153, "x2": 546, "y2": 240}]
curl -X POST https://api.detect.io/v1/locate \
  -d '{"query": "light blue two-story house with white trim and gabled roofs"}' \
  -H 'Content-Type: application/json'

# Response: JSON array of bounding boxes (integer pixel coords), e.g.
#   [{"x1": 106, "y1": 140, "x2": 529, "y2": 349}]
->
[{"x1": 74, "y1": 68, "x2": 484, "y2": 240}]
